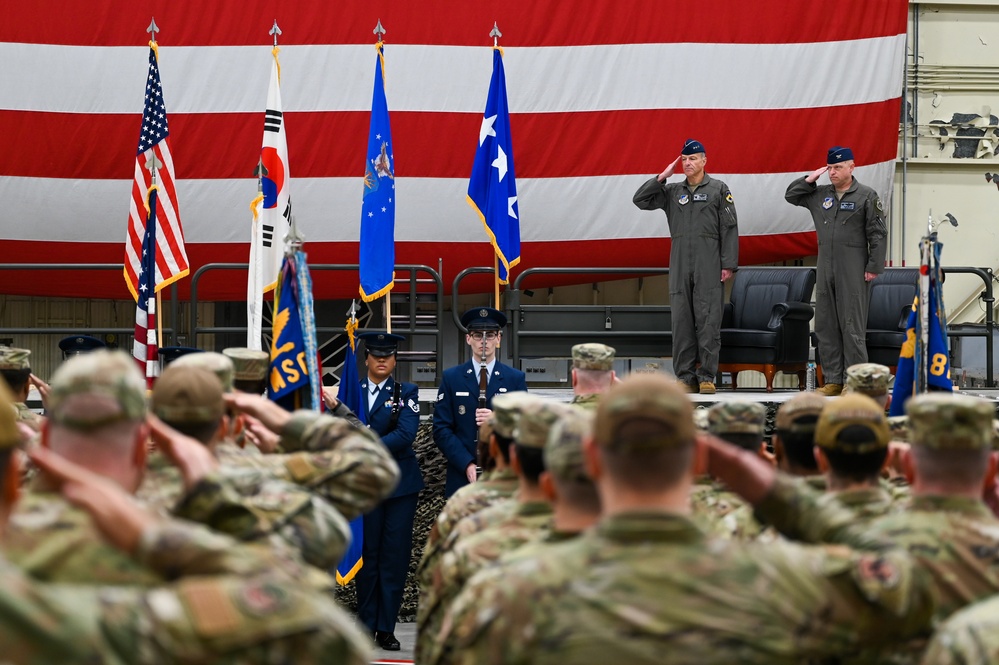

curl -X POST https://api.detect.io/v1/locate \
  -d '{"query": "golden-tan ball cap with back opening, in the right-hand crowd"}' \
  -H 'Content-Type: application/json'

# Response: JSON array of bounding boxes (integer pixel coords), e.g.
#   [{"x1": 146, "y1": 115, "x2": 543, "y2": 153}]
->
[{"x1": 815, "y1": 393, "x2": 891, "y2": 455}]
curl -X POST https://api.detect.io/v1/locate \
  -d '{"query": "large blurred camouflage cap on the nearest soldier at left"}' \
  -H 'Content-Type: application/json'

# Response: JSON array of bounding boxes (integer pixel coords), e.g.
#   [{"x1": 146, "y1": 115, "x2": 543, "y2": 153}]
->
[{"x1": 46, "y1": 349, "x2": 146, "y2": 432}]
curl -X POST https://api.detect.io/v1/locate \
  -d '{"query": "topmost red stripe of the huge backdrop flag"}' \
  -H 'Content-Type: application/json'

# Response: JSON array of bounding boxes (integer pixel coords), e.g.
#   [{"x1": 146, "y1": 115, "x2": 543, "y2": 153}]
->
[{"x1": 0, "y1": 0, "x2": 908, "y2": 46}]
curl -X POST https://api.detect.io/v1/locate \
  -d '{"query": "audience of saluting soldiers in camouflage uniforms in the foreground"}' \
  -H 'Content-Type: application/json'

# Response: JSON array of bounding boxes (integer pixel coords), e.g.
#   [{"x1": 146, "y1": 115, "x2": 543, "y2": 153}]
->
[{"x1": 0, "y1": 332, "x2": 999, "y2": 665}]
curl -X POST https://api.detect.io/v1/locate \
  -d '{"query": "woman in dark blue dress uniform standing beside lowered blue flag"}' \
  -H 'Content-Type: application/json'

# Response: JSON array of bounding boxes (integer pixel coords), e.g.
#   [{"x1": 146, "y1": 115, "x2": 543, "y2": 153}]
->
[{"x1": 355, "y1": 332, "x2": 423, "y2": 651}]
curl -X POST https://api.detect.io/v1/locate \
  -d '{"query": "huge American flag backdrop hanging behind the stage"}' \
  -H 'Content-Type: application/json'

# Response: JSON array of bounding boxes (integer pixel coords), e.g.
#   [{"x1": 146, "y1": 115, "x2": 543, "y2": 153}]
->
[{"x1": 0, "y1": 0, "x2": 907, "y2": 300}]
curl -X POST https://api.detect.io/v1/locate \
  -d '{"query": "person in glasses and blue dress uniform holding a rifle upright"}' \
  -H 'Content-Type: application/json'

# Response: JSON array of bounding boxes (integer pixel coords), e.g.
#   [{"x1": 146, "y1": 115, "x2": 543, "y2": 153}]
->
[{"x1": 434, "y1": 307, "x2": 527, "y2": 497}]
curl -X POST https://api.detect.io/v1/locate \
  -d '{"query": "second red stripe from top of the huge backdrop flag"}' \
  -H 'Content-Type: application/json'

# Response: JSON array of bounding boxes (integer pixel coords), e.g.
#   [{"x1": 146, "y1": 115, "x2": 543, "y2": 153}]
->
[{"x1": 0, "y1": 99, "x2": 899, "y2": 180}]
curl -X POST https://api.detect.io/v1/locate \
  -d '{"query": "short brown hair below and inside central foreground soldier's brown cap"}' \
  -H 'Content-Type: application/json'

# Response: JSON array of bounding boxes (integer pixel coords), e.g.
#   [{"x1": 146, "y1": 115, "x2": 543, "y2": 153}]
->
[{"x1": 600, "y1": 418, "x2": 694, "y2": 492}]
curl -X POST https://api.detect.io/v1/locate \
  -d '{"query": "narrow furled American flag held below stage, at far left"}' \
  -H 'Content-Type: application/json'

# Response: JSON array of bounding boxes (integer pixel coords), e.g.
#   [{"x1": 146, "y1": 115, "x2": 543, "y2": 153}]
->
[{"x1": 132, "y1": 184, "x2": 160, "y2": 388}]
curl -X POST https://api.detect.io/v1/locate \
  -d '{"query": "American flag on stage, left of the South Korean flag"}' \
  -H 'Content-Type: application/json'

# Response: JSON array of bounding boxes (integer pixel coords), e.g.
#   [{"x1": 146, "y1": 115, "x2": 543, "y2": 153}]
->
[{"x1": 125, "y1": 41, "x2": 189, "y2": 298}]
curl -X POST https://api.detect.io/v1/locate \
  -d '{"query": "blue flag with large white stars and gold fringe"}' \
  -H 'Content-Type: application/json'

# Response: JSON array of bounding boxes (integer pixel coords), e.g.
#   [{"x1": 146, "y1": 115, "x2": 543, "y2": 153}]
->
[{"x1": 468, "y1": 48, "x2": 520, "y2": 284}]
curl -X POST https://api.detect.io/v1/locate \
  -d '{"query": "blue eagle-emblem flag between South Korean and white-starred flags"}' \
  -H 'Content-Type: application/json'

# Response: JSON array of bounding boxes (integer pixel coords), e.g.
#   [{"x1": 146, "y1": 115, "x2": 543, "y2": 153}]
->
[{"x1": 359, "y1": 42, "x2": 395, "y2": 302}]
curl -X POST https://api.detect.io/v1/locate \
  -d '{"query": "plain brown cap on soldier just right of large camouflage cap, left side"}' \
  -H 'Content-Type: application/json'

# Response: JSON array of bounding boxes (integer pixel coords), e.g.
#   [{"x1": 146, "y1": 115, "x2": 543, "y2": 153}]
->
[{"x1": 149, "y1": 366, "x2": 225, "y2": 425}]
